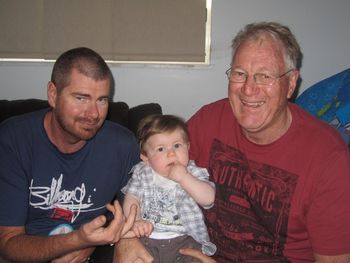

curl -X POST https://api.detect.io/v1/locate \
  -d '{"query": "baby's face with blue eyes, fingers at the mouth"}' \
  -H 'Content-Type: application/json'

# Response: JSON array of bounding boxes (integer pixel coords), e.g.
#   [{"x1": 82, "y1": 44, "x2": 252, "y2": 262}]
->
[{"x1": 141, "y1": 129, "x2": 189, "y2": 176}]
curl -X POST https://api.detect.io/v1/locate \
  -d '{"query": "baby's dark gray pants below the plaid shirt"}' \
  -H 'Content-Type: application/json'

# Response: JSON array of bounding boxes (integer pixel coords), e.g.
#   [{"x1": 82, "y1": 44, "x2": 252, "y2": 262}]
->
[{"x1": 141, "y1": 235, "x2": 201, "y2": 263}]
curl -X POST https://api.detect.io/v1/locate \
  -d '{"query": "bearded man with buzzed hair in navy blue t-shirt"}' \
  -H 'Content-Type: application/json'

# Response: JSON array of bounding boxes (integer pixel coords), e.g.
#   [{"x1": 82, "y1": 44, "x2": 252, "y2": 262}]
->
[{"x1": 0, "y1": 48, "x2": 139, "y2": 263}]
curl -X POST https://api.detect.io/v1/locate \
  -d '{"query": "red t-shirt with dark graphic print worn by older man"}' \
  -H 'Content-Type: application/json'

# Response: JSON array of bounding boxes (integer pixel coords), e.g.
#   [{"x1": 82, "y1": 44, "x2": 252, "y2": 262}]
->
[{"x1": 188, "y1": 99, "x2": 350, "y2": 263}]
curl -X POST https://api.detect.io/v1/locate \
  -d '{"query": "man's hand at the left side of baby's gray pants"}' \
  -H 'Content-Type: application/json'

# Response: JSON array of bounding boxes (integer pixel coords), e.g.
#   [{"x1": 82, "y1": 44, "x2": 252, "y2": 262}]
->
[{"x1": 113, "y1": 238, "x2": 153, "y2": 263}]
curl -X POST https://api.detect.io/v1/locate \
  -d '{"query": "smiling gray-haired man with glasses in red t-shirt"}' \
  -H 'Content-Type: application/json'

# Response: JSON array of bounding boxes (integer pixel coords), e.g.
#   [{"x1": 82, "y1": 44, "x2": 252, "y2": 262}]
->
[{"x1": 188, "y1": 22, "x2": 350, "y2": 263}]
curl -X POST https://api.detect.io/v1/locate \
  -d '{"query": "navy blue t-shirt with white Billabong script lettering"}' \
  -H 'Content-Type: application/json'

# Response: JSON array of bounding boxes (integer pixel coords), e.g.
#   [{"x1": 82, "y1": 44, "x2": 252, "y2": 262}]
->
[{"x1": 0, "y1": 110, "x2": 140, "y2": 235}]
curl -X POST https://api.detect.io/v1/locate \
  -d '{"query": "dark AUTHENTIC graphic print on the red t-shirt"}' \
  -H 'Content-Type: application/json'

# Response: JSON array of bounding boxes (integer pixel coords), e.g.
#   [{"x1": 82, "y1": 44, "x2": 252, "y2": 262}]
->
[{"x1": 206, "y1": 140, "x2": 297, "y2": 263}]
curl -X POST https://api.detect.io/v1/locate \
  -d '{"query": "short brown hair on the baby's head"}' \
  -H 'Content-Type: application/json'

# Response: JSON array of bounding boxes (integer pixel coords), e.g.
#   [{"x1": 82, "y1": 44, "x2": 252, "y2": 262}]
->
[{"x1": 137, "y1": 114, "x2": 189, "y2": 154}]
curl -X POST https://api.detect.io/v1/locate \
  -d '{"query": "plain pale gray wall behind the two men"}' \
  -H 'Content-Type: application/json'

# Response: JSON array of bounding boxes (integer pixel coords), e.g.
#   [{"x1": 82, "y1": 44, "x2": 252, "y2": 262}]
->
[{"x1": 0, "y1": 0, "x2": 350, "y2": 118}]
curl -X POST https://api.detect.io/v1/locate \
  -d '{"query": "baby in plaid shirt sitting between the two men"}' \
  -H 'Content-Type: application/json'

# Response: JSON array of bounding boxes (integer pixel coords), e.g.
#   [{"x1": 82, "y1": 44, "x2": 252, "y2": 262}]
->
[{"x1": 122, "y1": 115, "x2": 216, "y2": 262}]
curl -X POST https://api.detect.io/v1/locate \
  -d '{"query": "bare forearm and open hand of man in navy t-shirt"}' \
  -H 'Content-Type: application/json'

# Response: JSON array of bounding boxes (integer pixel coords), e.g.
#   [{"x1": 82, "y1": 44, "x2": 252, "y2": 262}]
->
[{"x1": 0, "y1": 202, "x2": 136, "y2": 262}]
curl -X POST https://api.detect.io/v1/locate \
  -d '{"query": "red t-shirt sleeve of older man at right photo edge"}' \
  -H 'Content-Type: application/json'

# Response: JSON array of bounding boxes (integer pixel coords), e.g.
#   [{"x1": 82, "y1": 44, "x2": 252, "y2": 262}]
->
[{"x1": 306, "y1": 149, "x2": 350, "y2": 255}]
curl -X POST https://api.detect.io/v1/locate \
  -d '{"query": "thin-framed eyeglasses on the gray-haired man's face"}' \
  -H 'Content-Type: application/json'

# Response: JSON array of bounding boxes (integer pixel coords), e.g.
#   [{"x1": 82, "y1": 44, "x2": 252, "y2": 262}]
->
[{"x1": 225, "y1": 68, "x2": 294, "y2": 85}]
